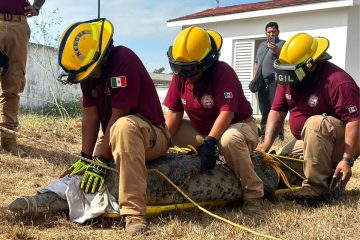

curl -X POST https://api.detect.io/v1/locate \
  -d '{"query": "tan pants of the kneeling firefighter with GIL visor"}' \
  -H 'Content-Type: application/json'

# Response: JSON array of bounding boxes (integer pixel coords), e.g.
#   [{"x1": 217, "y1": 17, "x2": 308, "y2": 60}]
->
[{"x1": 279, "y1": 115, "x2": 345, "y2": 192}]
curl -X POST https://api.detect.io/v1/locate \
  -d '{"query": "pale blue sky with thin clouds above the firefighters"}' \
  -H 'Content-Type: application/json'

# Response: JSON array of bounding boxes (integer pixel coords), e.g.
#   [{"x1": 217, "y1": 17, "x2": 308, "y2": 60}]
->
[{"x1": 29, "y1": 0, "x2": 260, "y2": 73}]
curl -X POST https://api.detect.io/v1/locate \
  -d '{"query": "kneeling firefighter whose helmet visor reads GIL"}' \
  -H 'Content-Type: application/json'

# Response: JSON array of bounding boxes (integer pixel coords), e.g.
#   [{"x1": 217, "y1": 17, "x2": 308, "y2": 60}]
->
[{"x1": 257, "y1": 33, "x2": 360, "y2": 202}]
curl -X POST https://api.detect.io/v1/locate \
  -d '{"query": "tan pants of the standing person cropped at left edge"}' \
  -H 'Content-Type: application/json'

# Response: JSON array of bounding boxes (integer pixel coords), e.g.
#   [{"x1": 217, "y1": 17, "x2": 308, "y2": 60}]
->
[{"x1": 0, "y1": 18, "x2": 30, "y2": 137}]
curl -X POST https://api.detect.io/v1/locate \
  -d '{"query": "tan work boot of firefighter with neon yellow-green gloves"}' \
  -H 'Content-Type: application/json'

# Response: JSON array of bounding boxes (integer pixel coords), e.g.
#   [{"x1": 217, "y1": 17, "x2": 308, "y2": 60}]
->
[{"x1": 125, "y1": 215, "x2": 150, "y2": 237}]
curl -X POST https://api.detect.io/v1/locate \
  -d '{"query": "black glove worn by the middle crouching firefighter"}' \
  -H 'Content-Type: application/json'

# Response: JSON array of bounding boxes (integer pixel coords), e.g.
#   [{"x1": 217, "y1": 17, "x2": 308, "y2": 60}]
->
[{"x1": 197, "y1": 136, "x2": 217, "y2": 171}]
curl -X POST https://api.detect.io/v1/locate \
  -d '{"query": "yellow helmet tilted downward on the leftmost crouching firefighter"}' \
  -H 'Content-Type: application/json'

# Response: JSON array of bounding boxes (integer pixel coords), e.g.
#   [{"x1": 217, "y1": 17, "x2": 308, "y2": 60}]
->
[{"x1": 58, "y1": 18, "x2": 113, "y2": 83}]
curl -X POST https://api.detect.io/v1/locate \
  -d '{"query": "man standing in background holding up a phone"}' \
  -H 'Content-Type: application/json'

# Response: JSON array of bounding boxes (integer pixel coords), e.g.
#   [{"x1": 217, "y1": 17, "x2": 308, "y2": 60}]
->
[{"x1": 254, "y1": 22, "x2": 285, "y2": 140}]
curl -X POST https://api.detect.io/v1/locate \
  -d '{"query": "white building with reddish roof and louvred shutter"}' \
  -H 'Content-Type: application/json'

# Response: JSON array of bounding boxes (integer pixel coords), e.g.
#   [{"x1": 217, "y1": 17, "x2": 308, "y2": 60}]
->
[{"x1": 167, "y1": 0, "x2": 360, "y2": 114}]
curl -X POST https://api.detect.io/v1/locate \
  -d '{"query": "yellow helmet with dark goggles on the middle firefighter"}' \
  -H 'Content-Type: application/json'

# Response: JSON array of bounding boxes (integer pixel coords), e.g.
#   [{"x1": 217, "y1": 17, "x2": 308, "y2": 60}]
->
[{"x1": 167, "y1": 26, "x2": 222, "y2": 78}]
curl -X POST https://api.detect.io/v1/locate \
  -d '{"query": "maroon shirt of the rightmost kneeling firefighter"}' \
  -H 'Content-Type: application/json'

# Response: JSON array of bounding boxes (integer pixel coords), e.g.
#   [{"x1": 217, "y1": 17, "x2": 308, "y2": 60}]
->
[{"x1": 272, "y1": 61, "x2": 360, "y2": 139}]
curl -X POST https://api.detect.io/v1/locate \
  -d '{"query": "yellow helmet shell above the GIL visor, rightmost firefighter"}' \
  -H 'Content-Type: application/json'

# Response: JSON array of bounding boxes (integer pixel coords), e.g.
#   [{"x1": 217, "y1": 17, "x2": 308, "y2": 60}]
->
[{"x1": 279, "y1": 33, "x2": 330, "y2": 64}]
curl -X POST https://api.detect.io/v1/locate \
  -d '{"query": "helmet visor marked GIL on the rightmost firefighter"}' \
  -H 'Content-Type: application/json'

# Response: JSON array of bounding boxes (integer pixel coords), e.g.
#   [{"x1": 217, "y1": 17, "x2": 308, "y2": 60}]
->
[{"x1": 274, "y1": 60, "x2": 310, "y2": 84}]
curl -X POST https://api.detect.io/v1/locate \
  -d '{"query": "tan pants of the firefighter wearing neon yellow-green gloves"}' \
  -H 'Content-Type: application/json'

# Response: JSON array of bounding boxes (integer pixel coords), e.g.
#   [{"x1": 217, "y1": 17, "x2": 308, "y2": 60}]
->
[{"x1": 110, "y1": 115, "x2": 170, "y2": 216}]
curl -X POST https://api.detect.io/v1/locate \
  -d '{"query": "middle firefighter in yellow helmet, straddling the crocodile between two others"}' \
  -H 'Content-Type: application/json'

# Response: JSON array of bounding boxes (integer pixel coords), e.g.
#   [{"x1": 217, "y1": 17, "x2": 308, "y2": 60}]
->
[{"x1": 164, "y1": 26, "x2": 264, "y2": 214}]
